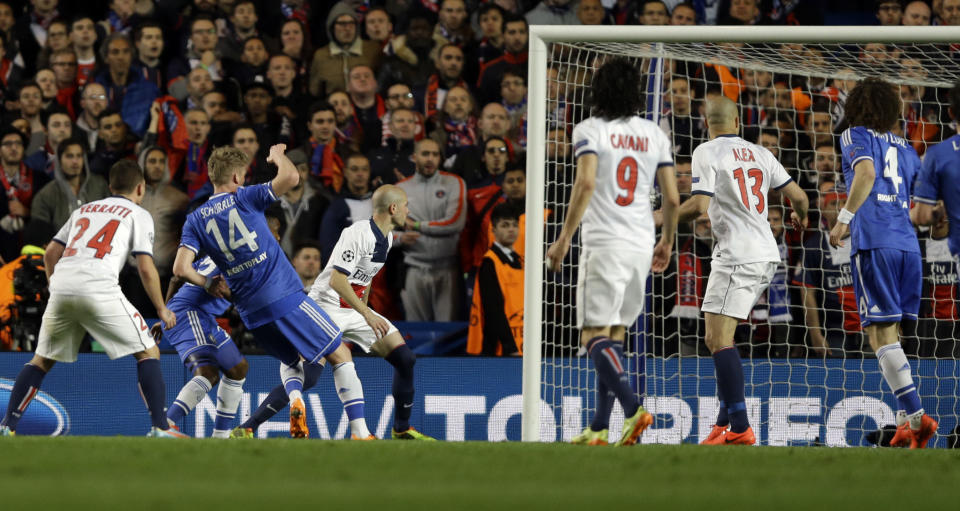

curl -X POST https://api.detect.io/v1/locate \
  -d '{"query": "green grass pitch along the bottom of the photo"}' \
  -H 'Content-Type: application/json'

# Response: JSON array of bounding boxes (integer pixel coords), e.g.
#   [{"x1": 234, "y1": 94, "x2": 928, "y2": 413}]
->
[{"x1": 0, "y1": 437, "x2": 960, "y2": 511}]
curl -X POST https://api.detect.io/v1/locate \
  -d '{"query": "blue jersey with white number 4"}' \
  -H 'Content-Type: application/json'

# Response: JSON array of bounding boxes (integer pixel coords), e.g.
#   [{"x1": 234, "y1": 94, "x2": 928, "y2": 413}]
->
[{"x1": 840, "y1": 126, "x2": 920, "y2": 254}]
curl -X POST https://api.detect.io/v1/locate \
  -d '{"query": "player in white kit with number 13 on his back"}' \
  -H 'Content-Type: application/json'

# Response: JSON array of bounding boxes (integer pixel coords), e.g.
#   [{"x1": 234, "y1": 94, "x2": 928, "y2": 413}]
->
[{"x1": 679, "y1": 96, "x2": 808, "y2": 445}]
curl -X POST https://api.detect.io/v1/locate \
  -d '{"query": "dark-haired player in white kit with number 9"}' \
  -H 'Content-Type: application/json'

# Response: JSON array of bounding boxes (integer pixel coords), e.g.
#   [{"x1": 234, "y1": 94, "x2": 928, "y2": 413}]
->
[{"x1": 546, "y1": 58, "x2": 680, "y2": 445}]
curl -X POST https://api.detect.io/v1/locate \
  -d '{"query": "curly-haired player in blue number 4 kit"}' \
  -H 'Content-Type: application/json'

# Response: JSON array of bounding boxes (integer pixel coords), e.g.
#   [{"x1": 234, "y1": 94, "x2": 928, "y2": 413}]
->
[{"x1": 830, "y1": 78, "x2": 937, "y2": 449}]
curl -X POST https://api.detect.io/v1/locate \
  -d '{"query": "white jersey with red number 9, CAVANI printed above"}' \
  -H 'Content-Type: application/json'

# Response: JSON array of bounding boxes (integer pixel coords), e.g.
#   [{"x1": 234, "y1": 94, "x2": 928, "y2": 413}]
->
[{"x1": 573, "y1": 116, "x2": 673, "y2": 251}]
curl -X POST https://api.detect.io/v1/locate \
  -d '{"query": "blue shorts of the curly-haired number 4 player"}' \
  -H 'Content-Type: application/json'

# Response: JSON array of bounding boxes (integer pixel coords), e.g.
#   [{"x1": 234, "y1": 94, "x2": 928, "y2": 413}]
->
[{"x1": 850, "y1": 248, "x2": 923, "y2": 326}]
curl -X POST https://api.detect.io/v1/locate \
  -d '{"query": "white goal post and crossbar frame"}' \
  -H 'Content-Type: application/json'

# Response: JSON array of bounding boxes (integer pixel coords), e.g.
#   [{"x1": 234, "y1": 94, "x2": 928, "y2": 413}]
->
[{"x1": 522, "y1": 25, "x2": 960, "y2": 442}]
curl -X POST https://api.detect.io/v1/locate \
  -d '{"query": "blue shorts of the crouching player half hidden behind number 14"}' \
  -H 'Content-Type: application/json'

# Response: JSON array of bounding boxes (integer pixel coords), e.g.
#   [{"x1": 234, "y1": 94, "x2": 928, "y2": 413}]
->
[{"x1": 163, "y1": 310, "x2": 243, "y2": 373}]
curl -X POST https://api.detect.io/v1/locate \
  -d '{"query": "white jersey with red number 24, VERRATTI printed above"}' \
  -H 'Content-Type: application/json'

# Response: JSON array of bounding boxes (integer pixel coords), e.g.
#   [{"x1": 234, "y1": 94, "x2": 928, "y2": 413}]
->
[{"x1": 50, "y1": 197, "x2": 153, "y2": 295}]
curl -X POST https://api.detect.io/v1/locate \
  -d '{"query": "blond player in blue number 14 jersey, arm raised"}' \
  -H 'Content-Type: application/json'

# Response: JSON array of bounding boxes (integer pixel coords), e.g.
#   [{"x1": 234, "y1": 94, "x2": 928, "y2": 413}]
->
[{"x1": 173, "y1": 144, "x2": 351, "y2": 438}]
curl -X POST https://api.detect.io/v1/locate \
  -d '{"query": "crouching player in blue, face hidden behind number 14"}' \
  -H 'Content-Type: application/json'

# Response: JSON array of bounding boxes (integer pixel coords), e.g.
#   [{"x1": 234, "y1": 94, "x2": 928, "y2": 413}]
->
[{"x1": 151, "y1": 257, "x2": 247, "y2": 438}]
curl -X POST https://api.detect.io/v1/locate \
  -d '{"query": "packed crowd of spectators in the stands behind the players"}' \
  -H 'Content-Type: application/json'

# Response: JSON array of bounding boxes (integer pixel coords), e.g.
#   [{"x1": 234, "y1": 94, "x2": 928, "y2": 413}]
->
[{"x1": 0, "y1": 0, "x2": 960, "y2": 355}]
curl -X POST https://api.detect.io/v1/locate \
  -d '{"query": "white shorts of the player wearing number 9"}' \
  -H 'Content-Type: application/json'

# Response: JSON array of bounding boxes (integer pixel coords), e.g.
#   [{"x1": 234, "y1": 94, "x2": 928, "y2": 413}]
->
[{"x1": 577, "y1": 249, "x2": 653, "y2": 328}]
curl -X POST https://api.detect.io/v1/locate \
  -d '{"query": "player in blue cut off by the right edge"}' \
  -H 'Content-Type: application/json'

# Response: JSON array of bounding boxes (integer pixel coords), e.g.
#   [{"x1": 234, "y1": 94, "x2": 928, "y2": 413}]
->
[{"x1": 913, "y1": 82, "x2": 960, "y2": 257}]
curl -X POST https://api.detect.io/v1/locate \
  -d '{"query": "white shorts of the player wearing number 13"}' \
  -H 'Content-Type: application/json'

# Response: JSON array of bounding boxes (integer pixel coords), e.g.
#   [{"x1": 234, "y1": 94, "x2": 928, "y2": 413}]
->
[{"x1": 700, "y1": 262, "x2": 779, "y2": 319}]
